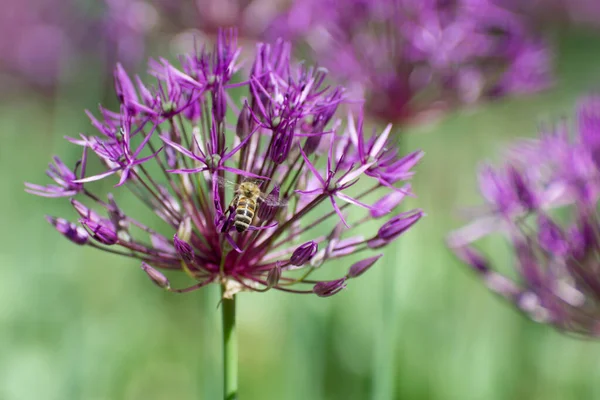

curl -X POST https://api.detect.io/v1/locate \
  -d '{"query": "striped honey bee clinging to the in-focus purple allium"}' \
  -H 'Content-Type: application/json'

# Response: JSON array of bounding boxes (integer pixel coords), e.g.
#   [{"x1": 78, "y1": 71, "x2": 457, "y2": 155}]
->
[{"x1": 217, "y1": 177, "x2": 287, "y2": 233}]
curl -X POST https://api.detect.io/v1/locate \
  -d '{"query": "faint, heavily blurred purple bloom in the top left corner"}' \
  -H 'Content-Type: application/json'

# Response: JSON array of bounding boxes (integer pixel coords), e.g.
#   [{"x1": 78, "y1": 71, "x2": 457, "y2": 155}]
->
[{"x1": 0, "y1": 0, "x2": 158, "y2": 90}]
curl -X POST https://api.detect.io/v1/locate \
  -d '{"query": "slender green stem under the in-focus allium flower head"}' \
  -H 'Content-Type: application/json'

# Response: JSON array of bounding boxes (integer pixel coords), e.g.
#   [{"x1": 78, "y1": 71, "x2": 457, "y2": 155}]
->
[{"x1": 221, "y1": 285, "x2": 238, "y2": 400}]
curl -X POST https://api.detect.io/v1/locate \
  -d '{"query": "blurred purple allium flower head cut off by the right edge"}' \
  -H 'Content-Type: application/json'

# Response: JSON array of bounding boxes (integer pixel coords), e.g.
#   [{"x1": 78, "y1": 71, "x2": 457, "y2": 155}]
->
[{"x1": 448, "y1": 96, "x2": 600, "y2": 336}]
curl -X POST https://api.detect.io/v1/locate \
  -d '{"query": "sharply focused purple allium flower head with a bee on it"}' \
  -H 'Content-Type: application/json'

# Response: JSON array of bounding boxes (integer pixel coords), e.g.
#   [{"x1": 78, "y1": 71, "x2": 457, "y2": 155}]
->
[{"x1": 27, "y1": 30, "x2": 422, "y2": 296}]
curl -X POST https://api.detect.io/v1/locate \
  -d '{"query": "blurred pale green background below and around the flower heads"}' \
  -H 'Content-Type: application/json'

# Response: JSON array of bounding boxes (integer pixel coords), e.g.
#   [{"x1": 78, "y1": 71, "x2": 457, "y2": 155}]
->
[{"x1": 0, "y1": 10, "x2": 600, "y2": 400}]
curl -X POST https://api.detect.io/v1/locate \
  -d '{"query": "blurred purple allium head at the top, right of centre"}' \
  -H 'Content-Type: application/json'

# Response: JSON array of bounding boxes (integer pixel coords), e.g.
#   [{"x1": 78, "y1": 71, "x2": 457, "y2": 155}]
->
[{"x1": 273, "y1": 0, "x2": 551, "y2": 121}]
